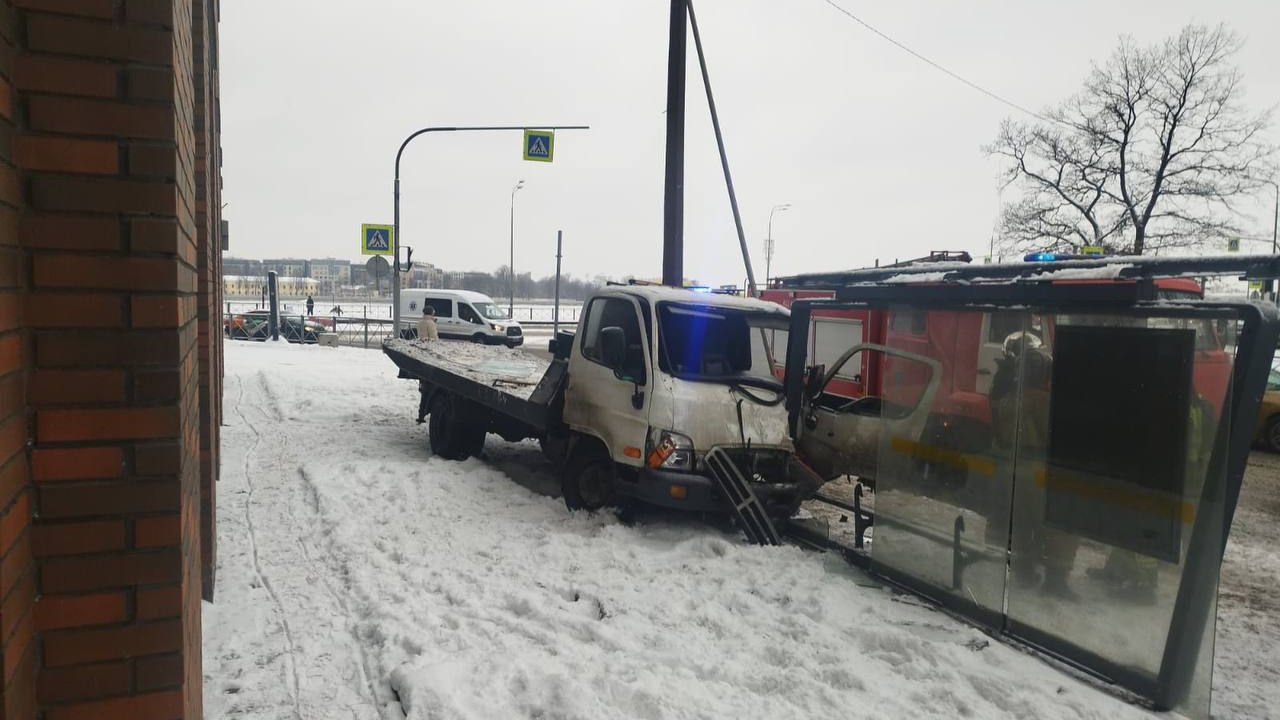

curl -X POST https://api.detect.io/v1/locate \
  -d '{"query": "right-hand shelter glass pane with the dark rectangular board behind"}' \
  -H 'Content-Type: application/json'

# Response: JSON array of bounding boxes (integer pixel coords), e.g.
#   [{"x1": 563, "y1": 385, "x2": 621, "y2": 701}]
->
[{"x1": 1007, "y1": 315, "x2": 1234, "y2": 717}]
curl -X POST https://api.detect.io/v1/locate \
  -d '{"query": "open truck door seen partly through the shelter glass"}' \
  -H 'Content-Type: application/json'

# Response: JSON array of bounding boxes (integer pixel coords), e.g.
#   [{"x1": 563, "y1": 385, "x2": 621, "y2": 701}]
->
[{"x1": 796, "y1": 343, "x2": 942, "y2": 480}]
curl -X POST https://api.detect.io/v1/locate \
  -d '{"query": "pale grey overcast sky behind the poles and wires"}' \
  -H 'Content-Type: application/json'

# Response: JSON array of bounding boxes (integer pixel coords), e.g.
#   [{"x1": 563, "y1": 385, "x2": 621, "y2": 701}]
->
[{"x1": 221, "y1": 0, "x2": 1280, "y2": 283}]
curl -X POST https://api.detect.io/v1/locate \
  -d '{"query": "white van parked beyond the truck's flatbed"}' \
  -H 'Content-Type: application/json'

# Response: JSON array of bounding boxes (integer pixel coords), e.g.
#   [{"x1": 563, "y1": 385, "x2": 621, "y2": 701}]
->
[{"x1": 401, "y1": 290, "x2": 525, "y2": 347}]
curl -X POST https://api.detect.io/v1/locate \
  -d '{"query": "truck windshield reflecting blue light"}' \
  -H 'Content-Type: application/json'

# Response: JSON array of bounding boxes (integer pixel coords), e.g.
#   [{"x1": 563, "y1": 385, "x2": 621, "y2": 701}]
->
[{"x1": 658, "y1": 302, "x2": 787, "y2": 389}]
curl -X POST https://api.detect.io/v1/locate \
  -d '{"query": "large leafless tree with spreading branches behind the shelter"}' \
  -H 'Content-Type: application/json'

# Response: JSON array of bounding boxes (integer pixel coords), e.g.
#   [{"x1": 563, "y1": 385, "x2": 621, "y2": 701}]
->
[{"x1": 987, "y1": 26, "x2": 1274, "y2": 255}]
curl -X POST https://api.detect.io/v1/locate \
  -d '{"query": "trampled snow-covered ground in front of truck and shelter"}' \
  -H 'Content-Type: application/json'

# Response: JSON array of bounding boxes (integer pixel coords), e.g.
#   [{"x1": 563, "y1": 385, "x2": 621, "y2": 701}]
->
[{"x1": 204, "y1": 342, "x2": 1280, "y2": 720}]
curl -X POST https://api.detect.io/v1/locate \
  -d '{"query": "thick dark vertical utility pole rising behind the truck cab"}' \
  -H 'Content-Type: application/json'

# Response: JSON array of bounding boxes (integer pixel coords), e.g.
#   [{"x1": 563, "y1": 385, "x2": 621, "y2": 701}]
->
[{"x1": 662, "y1": 0, "x2": 686, "y2": 287}]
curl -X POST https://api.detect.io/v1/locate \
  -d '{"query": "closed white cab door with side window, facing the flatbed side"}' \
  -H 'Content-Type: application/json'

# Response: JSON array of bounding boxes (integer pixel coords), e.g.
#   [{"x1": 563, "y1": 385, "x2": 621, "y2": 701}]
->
[{"x1": 564, "y1": 296, "x2": 653, "y2": 466}]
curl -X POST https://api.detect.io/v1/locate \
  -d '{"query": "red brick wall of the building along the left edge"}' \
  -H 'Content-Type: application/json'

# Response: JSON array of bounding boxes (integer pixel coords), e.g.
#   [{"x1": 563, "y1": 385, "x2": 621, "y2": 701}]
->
[{"x1": 0, "y1": 0, "x2": 221, "y2": 720}]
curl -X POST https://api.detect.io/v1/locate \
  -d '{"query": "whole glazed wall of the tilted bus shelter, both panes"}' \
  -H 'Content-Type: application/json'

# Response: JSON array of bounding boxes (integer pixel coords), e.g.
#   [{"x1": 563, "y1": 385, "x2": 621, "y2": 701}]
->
[{"x1": 870, "y1": 309, "x2": 1234, "y2": 716}]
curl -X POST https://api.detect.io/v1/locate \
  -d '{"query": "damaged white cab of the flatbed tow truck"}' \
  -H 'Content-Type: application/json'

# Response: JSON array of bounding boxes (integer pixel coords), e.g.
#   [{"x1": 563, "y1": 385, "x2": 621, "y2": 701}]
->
[{"x1": 553, "y1": 284, "x2": 819, "y2": 518}]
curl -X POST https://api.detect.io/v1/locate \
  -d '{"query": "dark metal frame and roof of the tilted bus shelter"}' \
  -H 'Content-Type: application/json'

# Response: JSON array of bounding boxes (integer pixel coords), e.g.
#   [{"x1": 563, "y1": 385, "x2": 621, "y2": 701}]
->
[{"x1": 782, "y1": 255, "x2": 1280, "y2": 710}]
